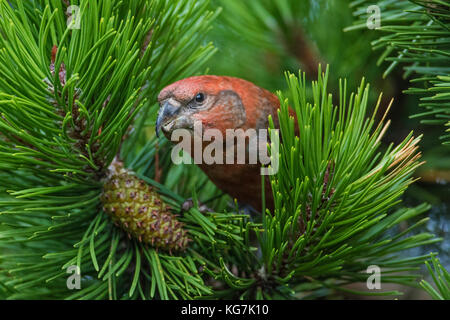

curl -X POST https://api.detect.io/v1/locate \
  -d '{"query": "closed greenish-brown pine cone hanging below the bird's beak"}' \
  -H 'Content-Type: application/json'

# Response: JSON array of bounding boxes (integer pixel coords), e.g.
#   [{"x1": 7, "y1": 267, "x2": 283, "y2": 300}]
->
[{"x1": 101, "y1": 161, "x2": 190, "y2": 251}]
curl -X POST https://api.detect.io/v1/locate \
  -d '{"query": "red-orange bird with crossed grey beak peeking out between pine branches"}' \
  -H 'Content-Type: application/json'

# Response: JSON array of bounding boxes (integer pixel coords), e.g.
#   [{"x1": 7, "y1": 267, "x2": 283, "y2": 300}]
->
[{"x1": 156, "y1": 76, "x2": 280, "y2": 210}]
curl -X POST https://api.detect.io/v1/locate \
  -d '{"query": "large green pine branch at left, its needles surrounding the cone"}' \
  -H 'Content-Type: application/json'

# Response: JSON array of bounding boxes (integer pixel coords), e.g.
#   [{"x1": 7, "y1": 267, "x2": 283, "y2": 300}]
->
[{"x1": 0, "y1": 0, "x2": 250, "y2": 299}]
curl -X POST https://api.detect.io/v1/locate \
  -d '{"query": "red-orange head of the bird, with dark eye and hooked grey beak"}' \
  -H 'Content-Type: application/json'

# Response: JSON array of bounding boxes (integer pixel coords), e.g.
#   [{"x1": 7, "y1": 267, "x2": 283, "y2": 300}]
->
[{"x1": 156, "y1": 76, "x2": 278, "y2": 139}]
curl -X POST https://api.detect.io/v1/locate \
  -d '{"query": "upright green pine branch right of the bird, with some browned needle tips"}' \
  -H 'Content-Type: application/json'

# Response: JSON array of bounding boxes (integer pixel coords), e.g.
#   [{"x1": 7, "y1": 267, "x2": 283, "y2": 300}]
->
[{"x1": 216, "y1": 68, "x2": 439, "y2": 299}]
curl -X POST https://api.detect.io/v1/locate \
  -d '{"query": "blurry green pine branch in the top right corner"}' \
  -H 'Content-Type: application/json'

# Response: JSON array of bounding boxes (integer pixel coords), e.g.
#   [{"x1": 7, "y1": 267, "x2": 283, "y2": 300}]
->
[{"x1": 346, "y1": 0, "x2": 450, "y2": 145}]
